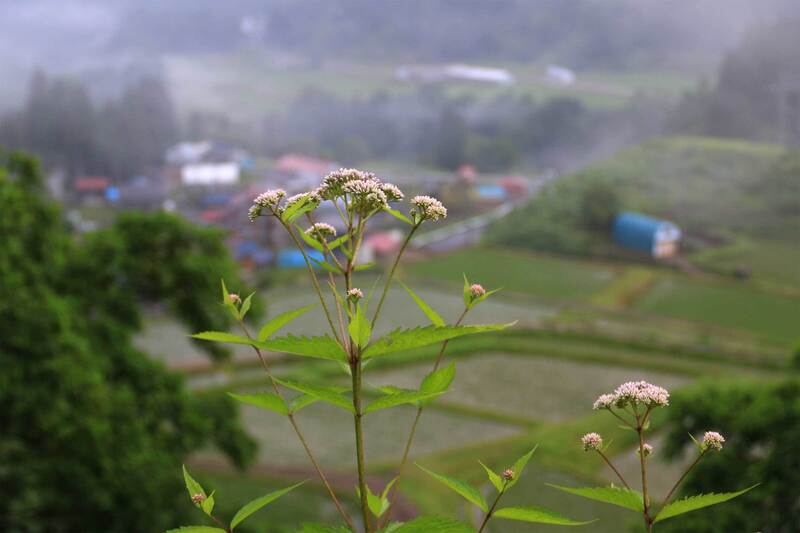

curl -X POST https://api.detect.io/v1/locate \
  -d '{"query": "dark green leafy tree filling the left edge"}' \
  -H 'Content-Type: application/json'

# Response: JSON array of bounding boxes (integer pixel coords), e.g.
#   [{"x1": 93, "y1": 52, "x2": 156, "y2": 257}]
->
[{"x1": 0, "y1": 152, "x2": 255, "y2": 531}]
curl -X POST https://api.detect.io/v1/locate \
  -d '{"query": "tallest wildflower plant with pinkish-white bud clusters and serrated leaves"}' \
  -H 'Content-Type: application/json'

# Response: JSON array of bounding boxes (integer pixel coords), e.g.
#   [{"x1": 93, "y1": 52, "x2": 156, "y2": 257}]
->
[{"x1": 169, "y1": 169, "x2": 582, "y2": 533}]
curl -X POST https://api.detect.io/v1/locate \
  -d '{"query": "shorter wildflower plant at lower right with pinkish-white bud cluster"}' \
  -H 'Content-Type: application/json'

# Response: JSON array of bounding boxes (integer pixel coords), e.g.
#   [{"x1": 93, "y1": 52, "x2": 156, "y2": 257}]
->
[{"x1": 551, "y1": 381, "x2": 755, "y2": 533}]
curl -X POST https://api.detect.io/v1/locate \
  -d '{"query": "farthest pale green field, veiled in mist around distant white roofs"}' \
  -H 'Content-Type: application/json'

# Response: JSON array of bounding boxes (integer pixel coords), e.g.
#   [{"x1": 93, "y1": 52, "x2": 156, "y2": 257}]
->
[{"x1": 165, "y1": 52, "x2": 695, "y2": 121}]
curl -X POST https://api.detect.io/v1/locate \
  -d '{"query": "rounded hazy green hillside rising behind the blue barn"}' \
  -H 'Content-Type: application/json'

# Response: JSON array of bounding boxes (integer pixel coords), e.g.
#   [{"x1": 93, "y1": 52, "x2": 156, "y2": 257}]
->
[{"x1": 487, "y1": 137, "x2": 800, "y2": 254}]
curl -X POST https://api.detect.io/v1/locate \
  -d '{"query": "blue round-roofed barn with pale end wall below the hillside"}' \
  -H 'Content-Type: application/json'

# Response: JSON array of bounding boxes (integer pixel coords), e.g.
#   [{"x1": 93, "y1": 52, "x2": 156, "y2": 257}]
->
[{"x1": 612, "y1": 212, "x2": 681, "y2": 257}]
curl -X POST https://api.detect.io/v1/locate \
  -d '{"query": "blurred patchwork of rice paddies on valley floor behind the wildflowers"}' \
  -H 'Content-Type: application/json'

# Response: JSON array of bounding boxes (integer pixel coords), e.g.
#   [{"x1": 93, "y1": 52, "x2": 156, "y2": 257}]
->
[{"x1": 147, "y1": 248, "x2": 800, "y2": 533}]
